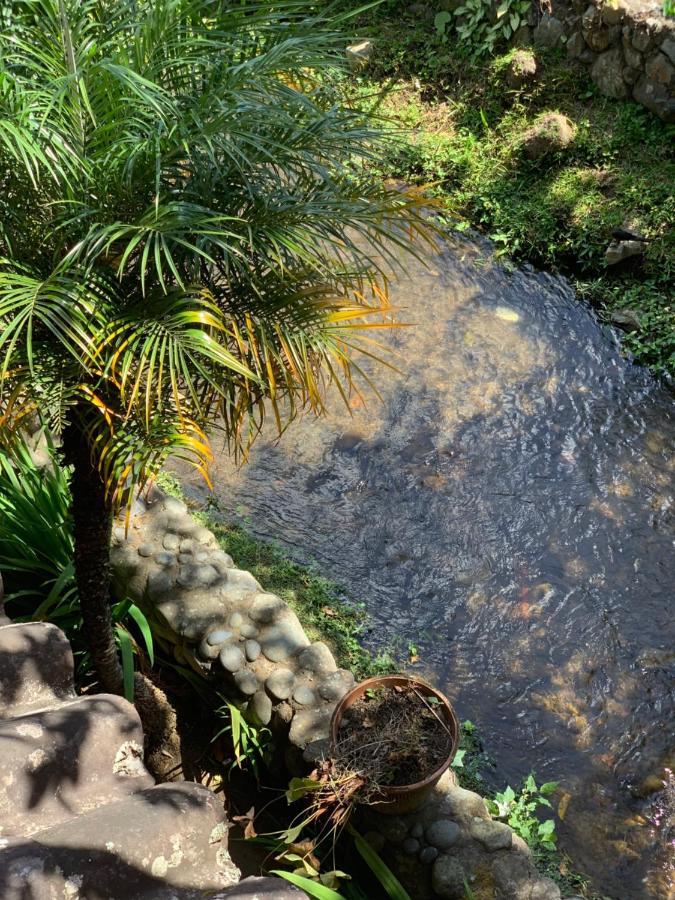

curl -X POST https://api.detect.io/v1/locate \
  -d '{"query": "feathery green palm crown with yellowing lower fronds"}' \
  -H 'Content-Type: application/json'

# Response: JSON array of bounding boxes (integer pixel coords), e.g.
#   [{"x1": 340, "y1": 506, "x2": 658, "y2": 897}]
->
[{"x1": 0, "y1": 0, "x2": 429, "y2": 501}]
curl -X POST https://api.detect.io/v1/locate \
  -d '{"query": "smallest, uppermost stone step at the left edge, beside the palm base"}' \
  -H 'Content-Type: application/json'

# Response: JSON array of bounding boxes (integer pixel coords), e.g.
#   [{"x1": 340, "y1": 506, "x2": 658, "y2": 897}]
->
[{"x1": 0, "y1": 622, "x2": 75, "y2": 719}]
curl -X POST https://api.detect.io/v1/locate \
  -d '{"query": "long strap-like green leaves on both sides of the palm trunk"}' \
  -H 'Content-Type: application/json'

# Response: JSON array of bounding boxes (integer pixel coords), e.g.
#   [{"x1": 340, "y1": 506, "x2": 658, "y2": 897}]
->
[{"x1": 0, "y1": 436, "x2": 154, "y2": 684}]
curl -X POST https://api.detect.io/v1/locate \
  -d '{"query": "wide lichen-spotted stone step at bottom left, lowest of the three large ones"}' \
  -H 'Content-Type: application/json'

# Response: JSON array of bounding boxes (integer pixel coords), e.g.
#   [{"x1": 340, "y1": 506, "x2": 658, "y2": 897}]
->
[{"x1": 0, "y1": 782, "x2": 242, "y2": 900}]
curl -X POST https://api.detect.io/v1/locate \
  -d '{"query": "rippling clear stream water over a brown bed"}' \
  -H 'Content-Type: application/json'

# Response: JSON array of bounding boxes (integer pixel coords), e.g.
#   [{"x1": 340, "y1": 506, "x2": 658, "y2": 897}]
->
[{"x1": 176, "y1": 236, "x2": 675, "y2": 900}]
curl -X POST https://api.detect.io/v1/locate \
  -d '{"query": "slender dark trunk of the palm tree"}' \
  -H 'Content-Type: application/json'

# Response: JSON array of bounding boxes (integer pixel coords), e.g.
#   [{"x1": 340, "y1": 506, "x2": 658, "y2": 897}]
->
[{"x1": 63, "y1": 411, "x2": 124, "y2": 694}]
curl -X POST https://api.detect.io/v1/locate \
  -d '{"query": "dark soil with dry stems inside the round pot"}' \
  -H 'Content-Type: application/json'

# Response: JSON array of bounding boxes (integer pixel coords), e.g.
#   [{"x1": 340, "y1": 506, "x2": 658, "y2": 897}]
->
[{"x1": 335, "y1": 685, "x2": 453, "y2": 787}]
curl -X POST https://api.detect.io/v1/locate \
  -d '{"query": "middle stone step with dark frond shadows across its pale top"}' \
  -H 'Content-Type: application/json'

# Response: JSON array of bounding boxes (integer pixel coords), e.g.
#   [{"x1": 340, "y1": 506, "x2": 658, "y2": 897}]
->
[{"x1": 0, "y1": 688, "x2": 153, "y2": 836}]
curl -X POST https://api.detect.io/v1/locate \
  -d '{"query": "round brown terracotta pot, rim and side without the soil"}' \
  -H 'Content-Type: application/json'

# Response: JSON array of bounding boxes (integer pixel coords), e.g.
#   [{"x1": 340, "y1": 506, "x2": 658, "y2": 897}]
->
[{"x1": 330, "y1": 675, "x2": 459, "y2": 816}]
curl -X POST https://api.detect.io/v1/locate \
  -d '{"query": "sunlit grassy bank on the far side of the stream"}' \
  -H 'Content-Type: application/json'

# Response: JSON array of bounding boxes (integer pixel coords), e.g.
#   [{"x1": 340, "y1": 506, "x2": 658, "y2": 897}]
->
[{"x1": 344, "y1": 2, "x2": 675, "y2": 373}]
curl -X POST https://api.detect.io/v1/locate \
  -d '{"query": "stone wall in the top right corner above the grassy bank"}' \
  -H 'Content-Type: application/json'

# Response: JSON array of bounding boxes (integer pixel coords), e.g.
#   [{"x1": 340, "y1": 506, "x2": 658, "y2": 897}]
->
[{"x1": 514, "y1": 0, "x2": 675, "y2": 122}]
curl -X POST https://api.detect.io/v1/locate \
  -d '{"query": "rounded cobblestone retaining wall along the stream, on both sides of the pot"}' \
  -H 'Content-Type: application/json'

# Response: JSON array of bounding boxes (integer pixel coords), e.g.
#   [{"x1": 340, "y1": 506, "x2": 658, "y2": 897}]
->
[{"x1": 112, "y1": 493, "x2": 580, "y2": 900}]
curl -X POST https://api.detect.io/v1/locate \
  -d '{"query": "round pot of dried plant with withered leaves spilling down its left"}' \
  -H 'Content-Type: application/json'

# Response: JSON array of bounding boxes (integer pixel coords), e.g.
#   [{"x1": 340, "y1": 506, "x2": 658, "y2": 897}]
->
[{"x1": 276, "y1": 675, "x2": 459, "y2": 896}]
